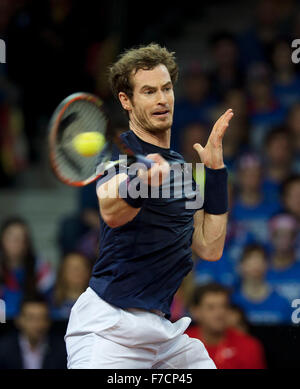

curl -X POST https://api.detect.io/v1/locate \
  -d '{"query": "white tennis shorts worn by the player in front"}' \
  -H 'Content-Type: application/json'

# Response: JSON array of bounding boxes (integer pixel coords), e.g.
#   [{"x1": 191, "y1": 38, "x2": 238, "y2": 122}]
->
[{"x1": 65, "y1": 287, "x2": 216, "y2": 369}]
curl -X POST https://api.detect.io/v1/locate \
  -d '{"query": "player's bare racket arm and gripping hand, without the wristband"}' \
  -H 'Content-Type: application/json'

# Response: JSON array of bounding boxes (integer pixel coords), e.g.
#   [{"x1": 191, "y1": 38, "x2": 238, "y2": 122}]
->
[{"x1": 97, "y1": 154, "x2": 170, "y2": 228}]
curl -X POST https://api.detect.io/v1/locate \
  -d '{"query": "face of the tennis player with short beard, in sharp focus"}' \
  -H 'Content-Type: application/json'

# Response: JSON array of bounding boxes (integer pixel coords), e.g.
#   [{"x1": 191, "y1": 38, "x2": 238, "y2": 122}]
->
[{"x1": 119, "y1": 65, "x2": 174, "y2": 133}]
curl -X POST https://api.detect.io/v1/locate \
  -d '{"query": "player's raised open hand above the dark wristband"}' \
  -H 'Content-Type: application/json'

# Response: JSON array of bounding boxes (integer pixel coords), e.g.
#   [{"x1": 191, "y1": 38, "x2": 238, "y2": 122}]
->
[{"x1": 193, "y1": 109, "x2": 233, "y2": 169}]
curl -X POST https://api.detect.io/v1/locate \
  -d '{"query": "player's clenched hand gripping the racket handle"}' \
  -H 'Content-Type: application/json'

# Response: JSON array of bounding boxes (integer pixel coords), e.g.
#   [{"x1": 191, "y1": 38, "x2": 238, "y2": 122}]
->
[{"x1": 138, "y1": 154, "x2": 170, "y2": 186}]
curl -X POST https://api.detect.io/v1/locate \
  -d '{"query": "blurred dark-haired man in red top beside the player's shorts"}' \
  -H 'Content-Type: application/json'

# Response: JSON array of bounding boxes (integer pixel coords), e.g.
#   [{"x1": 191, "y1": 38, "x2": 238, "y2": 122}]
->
[{"x1": 186, "y1": 283, "x2": 266, "y2": 369}]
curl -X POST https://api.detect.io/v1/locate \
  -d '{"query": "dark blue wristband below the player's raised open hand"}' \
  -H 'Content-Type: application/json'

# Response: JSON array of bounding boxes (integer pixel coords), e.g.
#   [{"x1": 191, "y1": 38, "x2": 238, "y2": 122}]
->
[{"x1": 203, "y1": 166, "x2": 228, "y2": 215}]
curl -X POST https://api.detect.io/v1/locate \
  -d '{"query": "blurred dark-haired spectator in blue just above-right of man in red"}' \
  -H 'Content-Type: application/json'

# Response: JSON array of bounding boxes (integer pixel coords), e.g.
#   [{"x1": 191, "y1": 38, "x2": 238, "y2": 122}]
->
[{"x1": 232, "y1": 245, "x2": 291, "y2": 325}]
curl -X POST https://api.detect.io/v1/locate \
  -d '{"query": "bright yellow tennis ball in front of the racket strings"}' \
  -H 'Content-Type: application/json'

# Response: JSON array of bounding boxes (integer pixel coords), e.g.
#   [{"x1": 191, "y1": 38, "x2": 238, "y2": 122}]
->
[{"x1": 72, "y1": 131, "x2": 105, "y2": 157}]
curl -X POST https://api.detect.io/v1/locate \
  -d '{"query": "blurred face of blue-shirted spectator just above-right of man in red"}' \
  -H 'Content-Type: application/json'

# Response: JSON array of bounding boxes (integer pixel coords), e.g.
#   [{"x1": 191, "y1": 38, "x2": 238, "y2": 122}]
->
[{"x1": 240, "y1": 251, "x2": 267, "y2": 280}]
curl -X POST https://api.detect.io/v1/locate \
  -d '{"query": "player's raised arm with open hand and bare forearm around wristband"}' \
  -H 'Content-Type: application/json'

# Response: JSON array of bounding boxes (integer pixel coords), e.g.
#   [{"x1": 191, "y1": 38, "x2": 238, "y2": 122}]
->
[{"x1": 192, "y1": 109, "x2": 233, "y2": 261}]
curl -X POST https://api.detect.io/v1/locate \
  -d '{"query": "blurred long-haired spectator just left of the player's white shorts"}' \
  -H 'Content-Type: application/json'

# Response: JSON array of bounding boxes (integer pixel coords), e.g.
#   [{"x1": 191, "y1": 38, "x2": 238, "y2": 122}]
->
[{"x1": 51, "y1": 252, "x2": 91, "y2": 320}]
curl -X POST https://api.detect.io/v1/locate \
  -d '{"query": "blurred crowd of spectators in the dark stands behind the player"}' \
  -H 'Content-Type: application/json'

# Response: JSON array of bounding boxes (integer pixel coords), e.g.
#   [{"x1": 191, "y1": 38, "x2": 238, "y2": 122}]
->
[{"x1": 0, "y1": 0, "x2": 300, "y2": 369}]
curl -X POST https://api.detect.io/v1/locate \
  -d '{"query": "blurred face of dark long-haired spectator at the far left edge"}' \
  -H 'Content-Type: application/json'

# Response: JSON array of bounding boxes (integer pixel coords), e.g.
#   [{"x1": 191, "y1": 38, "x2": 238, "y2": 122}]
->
[{"x1": 2, "y1": 224, "x2": 27, "y2": 257}]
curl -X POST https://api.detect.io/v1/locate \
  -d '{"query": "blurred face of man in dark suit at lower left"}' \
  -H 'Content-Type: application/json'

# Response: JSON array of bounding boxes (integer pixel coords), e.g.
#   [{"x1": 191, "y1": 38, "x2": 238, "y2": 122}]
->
[{"x1": 18, "y1": 303, "x2": 50, "y2": 342}]
